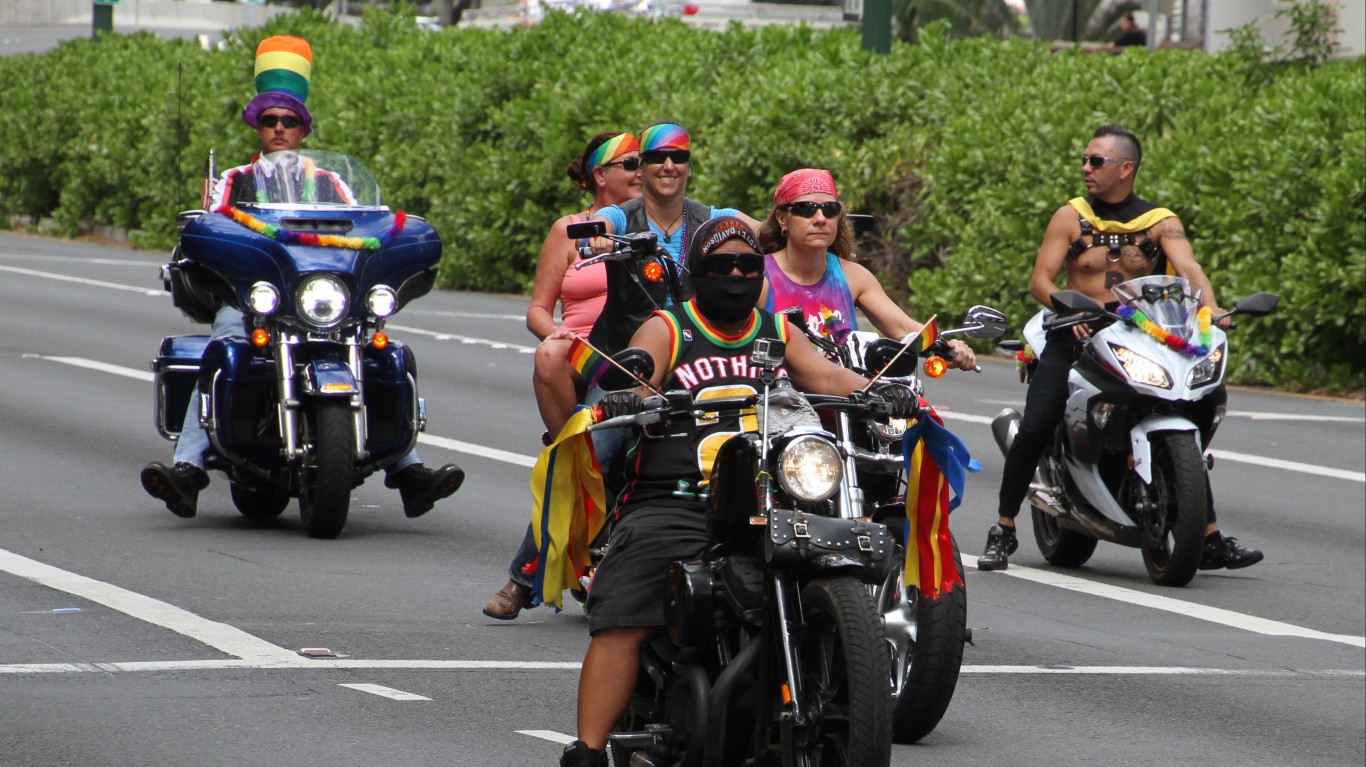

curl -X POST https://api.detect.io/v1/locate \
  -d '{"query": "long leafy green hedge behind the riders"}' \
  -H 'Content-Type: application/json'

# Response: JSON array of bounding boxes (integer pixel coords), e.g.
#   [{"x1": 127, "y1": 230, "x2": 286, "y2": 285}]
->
[{"x1": 0, "y1": 12, "x2": 1366, "y2": 391}]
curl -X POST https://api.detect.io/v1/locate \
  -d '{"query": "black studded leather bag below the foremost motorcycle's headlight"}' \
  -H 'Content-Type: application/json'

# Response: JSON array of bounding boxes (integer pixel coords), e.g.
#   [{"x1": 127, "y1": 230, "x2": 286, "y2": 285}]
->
[{"x1": 764, "y1": 509, "x2": 896, "y2": 584}]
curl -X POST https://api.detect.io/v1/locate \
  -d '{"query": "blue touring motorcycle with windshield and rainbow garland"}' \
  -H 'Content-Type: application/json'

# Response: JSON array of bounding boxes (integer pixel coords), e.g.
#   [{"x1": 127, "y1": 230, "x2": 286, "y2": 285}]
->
[{"x1": 152, "y1": 146, "x2": 441, "y2": 539}]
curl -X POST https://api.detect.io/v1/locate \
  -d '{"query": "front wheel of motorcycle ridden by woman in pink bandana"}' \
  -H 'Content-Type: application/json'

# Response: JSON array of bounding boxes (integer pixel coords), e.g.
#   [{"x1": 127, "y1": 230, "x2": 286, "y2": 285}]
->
[{"x1": 884, "y1": 539, "x2": 967, "y2": 744}]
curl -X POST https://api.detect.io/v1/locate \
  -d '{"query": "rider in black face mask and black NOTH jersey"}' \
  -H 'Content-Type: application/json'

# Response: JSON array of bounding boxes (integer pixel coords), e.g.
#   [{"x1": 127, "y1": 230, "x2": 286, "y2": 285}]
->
[{"x1": 560, "y1": 216, "x2": 915, "y2": 767}]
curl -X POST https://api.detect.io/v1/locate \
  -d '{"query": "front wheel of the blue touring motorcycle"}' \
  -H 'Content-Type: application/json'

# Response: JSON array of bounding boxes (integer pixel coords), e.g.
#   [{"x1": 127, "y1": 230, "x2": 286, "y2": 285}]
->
[{"x1": 299, "y1": 399, "x2": 355, "y2": 539}]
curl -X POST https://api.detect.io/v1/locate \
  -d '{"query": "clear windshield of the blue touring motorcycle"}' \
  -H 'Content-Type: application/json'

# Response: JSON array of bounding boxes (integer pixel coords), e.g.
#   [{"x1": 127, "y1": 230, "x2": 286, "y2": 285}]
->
[{"x1": 228, "y1": 149, "x2": 380, "y2": 208}]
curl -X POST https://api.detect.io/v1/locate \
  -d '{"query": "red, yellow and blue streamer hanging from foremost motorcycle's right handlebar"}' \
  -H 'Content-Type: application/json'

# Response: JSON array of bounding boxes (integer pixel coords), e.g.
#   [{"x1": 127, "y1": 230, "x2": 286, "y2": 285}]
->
[{"x1": 902, "y1": 407, "x2": 981, "y2": 599}]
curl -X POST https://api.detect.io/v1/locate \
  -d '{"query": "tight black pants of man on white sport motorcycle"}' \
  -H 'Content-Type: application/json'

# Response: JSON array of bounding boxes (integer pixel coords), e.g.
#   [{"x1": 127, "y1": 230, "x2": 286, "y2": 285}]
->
[{"x1": 997, "y1": 328, "x2": 1214, "y2": 525}]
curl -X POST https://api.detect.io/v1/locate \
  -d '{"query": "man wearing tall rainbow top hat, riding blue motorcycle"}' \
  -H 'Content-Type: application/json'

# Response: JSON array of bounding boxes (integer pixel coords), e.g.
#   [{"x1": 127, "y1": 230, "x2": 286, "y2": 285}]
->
[{"x1": 141, "y1": 36, "x2": 464, "y2": 518}]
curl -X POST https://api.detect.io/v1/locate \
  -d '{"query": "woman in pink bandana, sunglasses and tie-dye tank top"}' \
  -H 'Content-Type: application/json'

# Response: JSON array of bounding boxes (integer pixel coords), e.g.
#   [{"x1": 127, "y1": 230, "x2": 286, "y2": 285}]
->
[{"x1": 759, "y1": 168, "x2": 977, "y2": 371}]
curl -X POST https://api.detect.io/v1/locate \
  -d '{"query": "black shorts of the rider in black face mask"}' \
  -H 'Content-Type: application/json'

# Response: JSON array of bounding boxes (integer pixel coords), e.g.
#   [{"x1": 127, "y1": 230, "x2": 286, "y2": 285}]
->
[{"x1": 587, "y1": 507, "x2": 708, "y2": 633}]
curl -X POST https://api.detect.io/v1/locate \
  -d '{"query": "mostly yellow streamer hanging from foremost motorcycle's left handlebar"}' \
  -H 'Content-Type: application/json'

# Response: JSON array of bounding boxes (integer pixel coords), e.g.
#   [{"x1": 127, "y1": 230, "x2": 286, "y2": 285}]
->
[{"x1": 531, "y1": 407, "x2": 607, "y2": 613}]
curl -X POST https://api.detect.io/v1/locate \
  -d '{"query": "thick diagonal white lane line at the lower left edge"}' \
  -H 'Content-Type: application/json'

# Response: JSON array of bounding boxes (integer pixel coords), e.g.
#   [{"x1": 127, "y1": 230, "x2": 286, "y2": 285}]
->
[{"x1": 0, "y1": 548, "x2": 309, "y2": 666}]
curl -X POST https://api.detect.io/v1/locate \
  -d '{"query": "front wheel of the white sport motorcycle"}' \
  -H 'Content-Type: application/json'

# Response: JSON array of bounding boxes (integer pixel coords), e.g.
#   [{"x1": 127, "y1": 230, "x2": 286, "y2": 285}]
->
[{"x1": 1142, "y1": 432, "x2": 1209, "y2": 587}]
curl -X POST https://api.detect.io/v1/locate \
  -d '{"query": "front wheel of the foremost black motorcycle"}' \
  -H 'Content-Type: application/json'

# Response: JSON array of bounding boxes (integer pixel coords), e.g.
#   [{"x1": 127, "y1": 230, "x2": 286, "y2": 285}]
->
[{"x1": 792, "y1": 576, "x2": 892, "y2": 767}]
